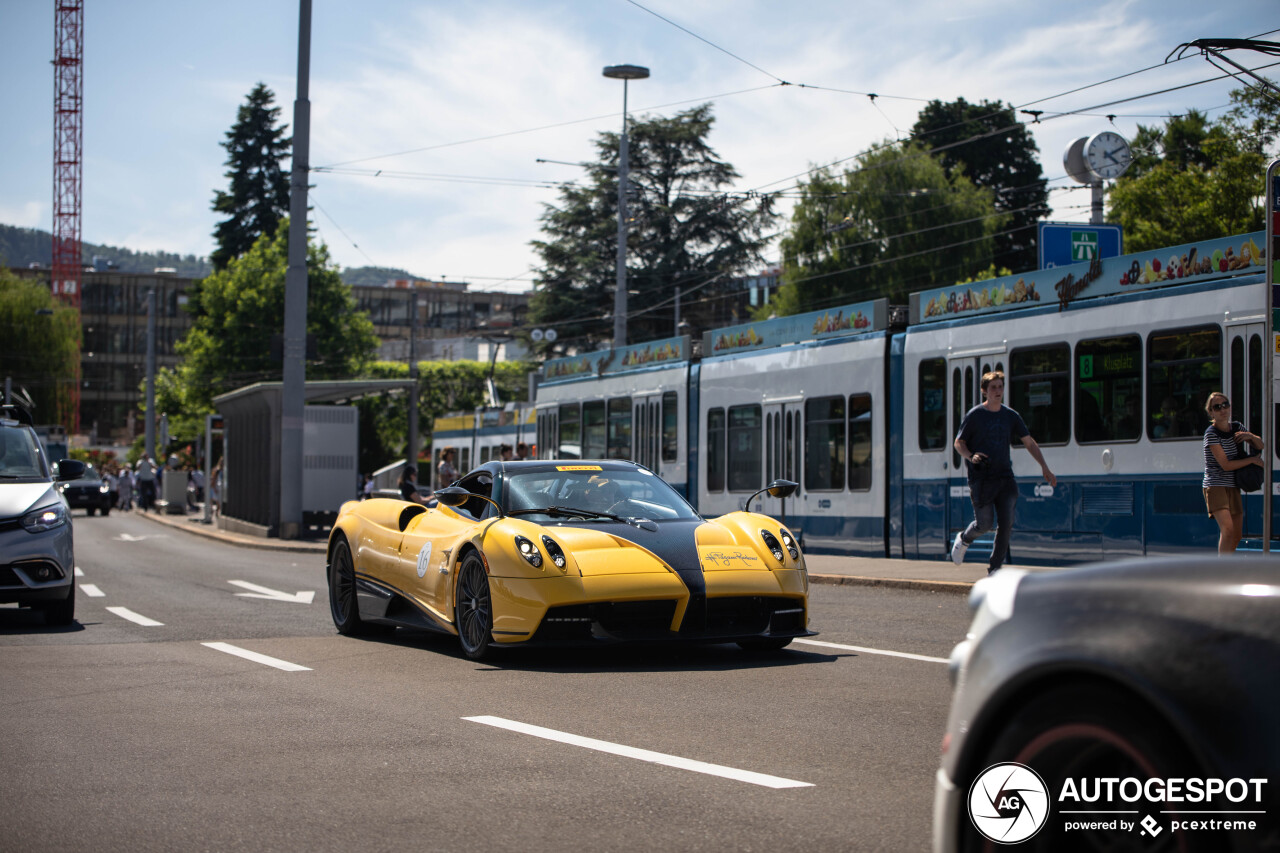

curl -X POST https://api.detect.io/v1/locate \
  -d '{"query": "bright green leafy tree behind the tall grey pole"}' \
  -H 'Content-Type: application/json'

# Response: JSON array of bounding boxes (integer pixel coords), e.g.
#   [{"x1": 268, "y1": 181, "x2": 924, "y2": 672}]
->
[{"x1": 156, "y1": 218, "x2": 378, "y2": 435}]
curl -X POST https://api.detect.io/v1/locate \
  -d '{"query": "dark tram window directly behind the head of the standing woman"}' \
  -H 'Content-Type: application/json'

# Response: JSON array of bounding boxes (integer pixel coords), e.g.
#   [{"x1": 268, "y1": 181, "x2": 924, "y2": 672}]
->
[{"x1": 1147, "y1": 325, "x2": 1222, "y2": 441}]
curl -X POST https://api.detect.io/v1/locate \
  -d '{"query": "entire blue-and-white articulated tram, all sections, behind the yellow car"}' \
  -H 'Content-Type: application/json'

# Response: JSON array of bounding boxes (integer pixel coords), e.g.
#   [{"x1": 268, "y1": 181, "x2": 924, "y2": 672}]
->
[{"x1": 536, "y1": 232, "x2": 1280, "y2": 565}]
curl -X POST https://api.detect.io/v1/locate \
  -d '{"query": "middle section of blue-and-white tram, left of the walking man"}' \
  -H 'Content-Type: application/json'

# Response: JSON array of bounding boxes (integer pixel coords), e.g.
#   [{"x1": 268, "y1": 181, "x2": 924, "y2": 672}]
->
[{"x1": 695, "y1": 300, "x2": 890, "y2": 555}]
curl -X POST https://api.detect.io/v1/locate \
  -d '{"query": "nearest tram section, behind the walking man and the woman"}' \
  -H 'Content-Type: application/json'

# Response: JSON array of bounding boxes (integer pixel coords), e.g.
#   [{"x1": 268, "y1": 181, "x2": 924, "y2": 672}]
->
[{"x1": 888, "y1": 233, "x2": 1276, "y2": 564}]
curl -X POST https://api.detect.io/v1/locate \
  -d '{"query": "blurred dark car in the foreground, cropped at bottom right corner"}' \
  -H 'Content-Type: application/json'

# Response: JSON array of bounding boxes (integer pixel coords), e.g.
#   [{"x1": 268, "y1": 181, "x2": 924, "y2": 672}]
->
[{"x1": 933, "y1": 555, "x2": 1280, "y2": 853}]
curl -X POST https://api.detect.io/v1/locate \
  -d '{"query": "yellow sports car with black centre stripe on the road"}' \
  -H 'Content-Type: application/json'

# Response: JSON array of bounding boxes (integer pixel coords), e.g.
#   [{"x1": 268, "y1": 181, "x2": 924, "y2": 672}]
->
[{"x1": 328, "y1": 460, "x2": 814, "y2": 660}]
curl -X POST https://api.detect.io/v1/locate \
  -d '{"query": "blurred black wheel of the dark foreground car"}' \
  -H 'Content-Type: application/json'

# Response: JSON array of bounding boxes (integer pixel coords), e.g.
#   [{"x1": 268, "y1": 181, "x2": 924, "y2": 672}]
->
[{"x1": 957, "y1": 684, "x2": 1221, "y2": 853}]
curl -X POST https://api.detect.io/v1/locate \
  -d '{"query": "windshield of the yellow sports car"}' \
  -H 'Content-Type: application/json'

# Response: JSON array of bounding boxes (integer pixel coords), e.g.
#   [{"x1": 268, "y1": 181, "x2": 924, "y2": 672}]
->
[{"x1": 503, "y1": 465, "x2": 698, "y2": 521}]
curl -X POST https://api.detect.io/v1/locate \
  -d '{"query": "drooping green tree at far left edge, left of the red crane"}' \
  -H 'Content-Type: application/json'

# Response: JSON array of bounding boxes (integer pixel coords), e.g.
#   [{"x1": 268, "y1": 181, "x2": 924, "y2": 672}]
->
[{"x1": 0, "y1": 266, "x2": 81, "y2": 424}]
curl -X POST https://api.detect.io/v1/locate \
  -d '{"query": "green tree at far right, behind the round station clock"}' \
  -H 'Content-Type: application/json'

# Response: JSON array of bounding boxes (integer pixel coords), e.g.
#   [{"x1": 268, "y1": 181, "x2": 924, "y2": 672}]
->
[{"x1": 1108, "y1": 90, "x2": 1276, "y2": 252}]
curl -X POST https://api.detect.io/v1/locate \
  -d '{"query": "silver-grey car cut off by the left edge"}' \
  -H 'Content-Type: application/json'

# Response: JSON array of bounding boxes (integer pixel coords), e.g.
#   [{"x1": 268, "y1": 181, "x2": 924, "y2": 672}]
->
[{"x1": 0, "y1": 415, "x2": 84, "y2": 625}]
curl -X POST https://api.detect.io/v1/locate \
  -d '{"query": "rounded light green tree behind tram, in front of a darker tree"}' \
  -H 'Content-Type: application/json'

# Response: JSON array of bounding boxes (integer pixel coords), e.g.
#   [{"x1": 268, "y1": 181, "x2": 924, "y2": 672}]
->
[{"x1": 769, "y1": 142, "x2": 1007, "y2": 315}]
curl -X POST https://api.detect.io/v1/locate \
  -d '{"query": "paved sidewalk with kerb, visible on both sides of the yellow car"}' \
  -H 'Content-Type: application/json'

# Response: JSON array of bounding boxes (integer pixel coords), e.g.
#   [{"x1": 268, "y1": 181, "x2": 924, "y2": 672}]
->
[{"x1": 136, "y1": 511, "x2": 1051, "y2": 594}]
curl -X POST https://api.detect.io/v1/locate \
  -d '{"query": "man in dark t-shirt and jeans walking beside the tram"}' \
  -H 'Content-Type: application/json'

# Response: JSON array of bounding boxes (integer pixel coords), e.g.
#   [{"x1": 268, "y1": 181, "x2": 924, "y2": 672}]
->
[{"x1": 951, "y1": 370, "x2": 1057, "y2": 574}]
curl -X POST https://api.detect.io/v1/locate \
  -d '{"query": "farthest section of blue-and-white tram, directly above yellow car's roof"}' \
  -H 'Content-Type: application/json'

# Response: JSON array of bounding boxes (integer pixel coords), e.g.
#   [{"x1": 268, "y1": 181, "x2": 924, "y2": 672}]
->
[{"x1": 538, "y1": 336, "x2": 690, "y2": 496}]
